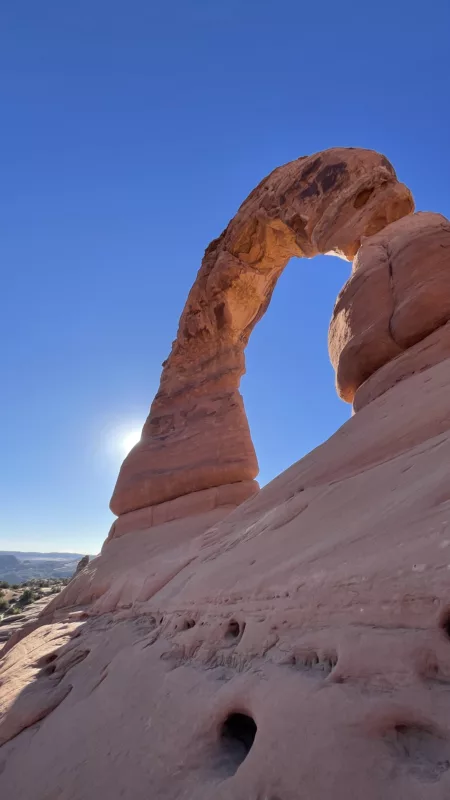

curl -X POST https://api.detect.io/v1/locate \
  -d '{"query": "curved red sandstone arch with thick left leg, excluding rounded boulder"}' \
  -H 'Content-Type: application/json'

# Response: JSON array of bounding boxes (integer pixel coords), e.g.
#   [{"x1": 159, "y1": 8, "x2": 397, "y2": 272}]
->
[{"x1": 111, "y1": 148, "x2": 413, "y2": 515}]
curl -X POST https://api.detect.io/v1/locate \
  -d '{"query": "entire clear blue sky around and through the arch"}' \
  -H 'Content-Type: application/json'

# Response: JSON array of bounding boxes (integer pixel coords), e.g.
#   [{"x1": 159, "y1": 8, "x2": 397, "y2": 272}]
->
[{"x1": 0, "y1": 0, "x2": 450, "y2": 552}]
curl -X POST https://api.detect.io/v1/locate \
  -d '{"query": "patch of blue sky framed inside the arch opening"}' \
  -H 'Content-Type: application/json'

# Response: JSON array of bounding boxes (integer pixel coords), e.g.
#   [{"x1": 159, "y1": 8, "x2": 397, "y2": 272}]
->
[{"x1": 240, "y1": 255, "x2": 351, "y2": 486}]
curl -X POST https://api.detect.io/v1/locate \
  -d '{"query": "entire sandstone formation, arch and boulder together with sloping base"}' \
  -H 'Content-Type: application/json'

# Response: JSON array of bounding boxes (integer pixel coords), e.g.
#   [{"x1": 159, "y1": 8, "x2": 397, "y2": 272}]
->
[{"x1": 4, "y1": 145, "x2": 450, "y2": 800}]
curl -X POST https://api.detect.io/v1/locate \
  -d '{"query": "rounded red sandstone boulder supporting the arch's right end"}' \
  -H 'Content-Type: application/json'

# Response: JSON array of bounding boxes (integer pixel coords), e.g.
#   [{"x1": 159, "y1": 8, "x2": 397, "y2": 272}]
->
[{"x1": 329, "y1": 213, "x2": 450, "y2": 402}]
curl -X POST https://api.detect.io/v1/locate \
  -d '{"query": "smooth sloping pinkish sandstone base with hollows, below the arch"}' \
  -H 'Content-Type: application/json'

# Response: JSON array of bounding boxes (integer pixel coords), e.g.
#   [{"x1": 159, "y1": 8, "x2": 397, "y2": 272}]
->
[{"x1": 4, "y1": 360, "x2": 450, "y2": 800}]
